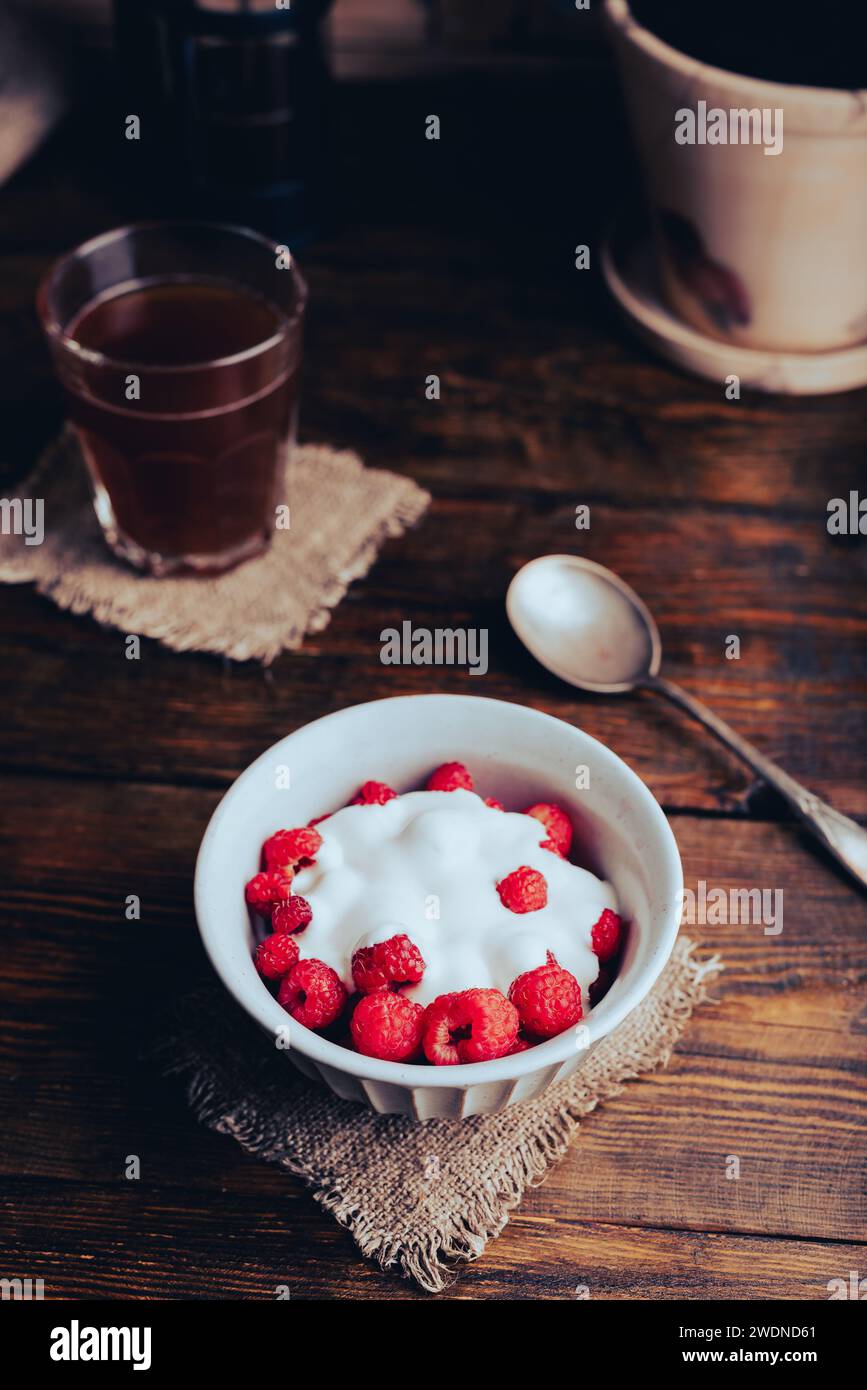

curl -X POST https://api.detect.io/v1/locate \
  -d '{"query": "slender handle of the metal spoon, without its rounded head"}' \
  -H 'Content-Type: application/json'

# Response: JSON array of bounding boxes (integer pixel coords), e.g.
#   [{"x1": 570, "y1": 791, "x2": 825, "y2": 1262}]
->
[{"x1": 645, "y1": 676, "x2": 867, "y2": 887}]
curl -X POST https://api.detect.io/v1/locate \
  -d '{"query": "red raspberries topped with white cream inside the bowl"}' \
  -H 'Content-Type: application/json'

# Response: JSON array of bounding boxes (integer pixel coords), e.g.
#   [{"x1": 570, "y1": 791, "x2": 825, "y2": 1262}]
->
[{"x1": 246, "y1": 763, "x2": 621, "y2": 1065}]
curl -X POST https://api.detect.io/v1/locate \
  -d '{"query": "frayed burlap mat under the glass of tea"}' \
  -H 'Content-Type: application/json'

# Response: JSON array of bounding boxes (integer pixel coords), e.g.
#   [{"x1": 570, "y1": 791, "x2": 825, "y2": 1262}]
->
[{"x1": 0, "y1": 434, "x2": 431, "y2": 663}]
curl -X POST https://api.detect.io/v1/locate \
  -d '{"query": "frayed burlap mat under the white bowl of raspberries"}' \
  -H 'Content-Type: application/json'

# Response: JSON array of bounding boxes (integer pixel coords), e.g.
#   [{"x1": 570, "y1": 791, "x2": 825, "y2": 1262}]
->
[{"x1": 154, "y1": 937, "x2": 721, "y2": 1293}]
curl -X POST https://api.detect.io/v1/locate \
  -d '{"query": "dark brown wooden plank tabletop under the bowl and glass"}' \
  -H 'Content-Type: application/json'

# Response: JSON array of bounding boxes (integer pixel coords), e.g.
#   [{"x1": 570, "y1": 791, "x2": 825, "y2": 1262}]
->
[{"x1": 0, "y1": 71, "x2": 867, "y2": 1300}]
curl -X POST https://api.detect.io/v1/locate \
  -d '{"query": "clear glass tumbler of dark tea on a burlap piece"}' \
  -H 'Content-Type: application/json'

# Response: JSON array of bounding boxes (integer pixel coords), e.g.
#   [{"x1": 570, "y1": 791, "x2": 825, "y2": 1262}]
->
[{"x1": 38, "y1": 222, "x2": 307, "y2": 575}]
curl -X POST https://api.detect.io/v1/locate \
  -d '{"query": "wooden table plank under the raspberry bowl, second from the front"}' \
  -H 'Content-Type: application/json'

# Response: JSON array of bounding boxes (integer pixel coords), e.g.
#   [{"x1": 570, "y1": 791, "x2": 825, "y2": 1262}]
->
[{"x1": 0, "y1": 778, "x2": 867, "y2": 1241}]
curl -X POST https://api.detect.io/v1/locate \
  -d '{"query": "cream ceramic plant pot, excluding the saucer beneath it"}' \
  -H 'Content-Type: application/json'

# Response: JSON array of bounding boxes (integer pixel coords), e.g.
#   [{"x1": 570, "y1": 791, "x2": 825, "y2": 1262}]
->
[{"x1": 604, "y1": 0, "x2": 867, "y2": 352}]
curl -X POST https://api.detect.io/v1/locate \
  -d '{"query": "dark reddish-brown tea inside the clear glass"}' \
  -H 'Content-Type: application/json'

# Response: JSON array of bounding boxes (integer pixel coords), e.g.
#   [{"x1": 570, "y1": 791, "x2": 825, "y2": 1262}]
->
[{"x1": 68, "y1": 281, "x2": 297, "y2": 569}]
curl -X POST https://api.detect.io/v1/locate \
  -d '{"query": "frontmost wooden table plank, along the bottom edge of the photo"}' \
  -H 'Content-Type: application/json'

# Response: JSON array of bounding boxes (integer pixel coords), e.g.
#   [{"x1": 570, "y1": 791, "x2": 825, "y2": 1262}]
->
[{"x1": 0, "y1": 1169, "x2": 864, "y2": 1301}]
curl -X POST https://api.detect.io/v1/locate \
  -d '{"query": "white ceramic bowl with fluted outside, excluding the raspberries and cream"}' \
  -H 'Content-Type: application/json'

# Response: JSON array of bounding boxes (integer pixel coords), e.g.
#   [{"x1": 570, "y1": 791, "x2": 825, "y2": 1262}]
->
[{"x1": 196, "y1": 695, "x2": 684, "y2": 1120}]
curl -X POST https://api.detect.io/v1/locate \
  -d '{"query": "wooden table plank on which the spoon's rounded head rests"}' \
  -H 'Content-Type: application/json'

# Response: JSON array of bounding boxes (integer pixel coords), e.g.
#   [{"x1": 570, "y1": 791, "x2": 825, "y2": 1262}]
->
[{"x1": 0, "y1": 483, "x2": 867, "y2": 815}]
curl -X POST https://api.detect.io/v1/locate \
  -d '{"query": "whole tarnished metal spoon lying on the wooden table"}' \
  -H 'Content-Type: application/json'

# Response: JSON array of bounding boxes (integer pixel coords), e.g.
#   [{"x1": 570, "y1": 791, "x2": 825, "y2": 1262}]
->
[{"x1": 506, "y1": 555, "x2": 867, "y2": 887}]
